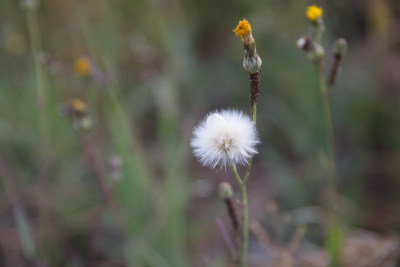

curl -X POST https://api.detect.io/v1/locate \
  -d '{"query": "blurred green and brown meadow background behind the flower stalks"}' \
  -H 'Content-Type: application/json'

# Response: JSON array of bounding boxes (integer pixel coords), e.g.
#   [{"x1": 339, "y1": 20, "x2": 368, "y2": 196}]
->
[{"x1": 0, "y1": 0, "x2": 400, "y2": 267}]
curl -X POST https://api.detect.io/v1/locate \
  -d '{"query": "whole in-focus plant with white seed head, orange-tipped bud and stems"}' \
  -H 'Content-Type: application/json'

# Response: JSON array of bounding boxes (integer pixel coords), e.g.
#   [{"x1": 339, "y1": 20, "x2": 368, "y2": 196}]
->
[{"x1": 190, "y1": 19, "x2": 262, "y2": 267}]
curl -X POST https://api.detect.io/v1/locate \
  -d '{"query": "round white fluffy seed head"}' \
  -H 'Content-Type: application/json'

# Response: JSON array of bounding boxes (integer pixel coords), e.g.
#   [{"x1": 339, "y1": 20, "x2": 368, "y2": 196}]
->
[{"x1": 191, "y1": 110, "x2": 259, "y2": 169}]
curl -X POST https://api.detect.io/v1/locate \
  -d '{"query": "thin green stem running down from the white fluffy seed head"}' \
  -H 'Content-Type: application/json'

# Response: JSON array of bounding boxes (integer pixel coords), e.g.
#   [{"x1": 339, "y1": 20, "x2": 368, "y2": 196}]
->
[{"x1": 231, "y1": 164, "x2": 249, "y2": 267}]
